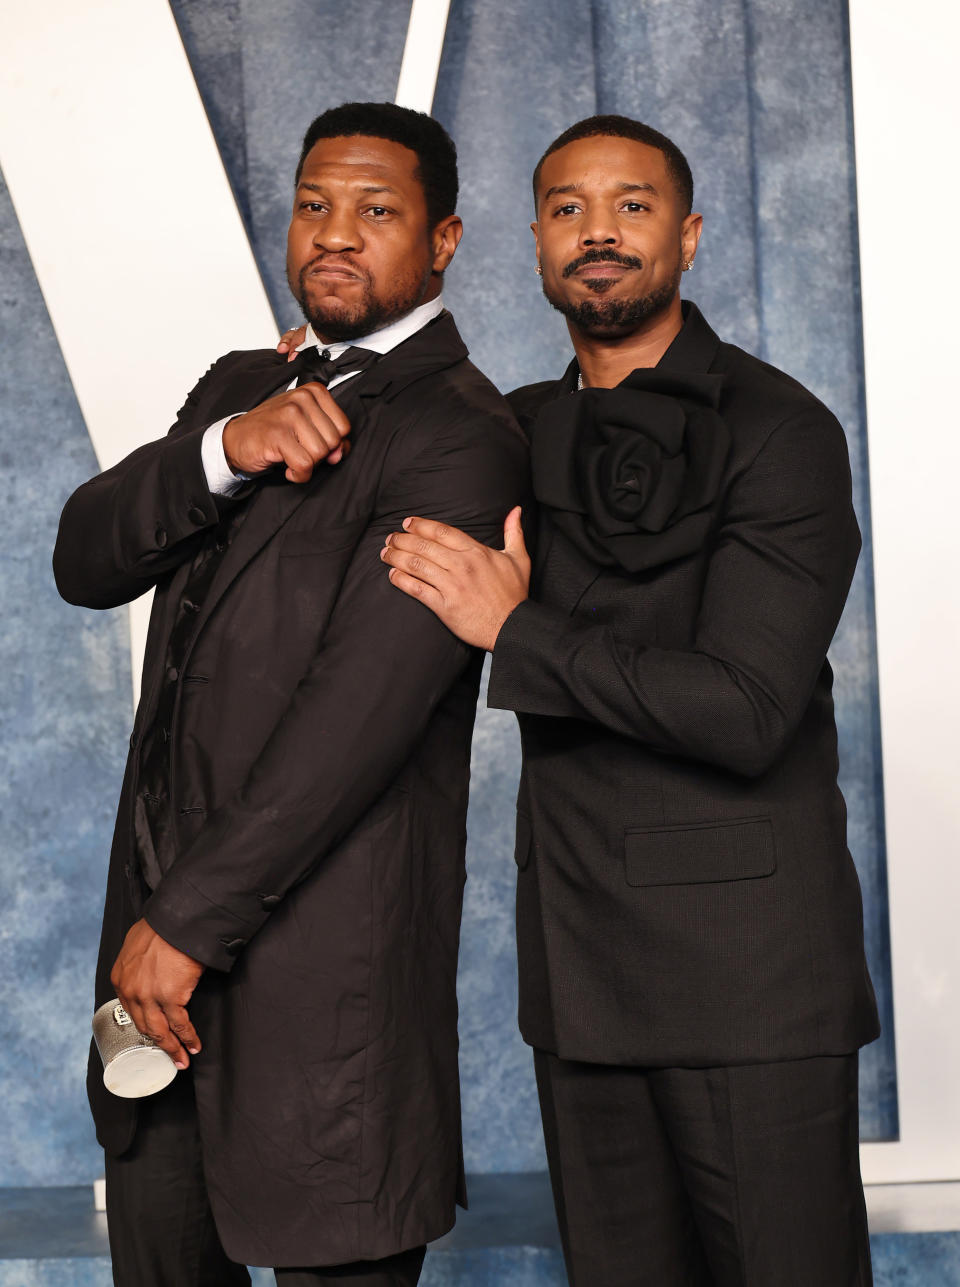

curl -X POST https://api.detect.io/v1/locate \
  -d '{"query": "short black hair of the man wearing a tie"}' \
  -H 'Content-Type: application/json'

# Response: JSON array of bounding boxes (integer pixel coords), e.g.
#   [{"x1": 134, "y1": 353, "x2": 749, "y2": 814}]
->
[{"x1": 295, "y1": 103, "x2": 459, "y2": 228}]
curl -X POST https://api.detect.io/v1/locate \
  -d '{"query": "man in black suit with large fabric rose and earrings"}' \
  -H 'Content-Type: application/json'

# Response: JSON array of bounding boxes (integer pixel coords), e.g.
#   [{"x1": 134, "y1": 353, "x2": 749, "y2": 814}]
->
[{"x1": 382, "y1": 117, "x2": 878, "y2": 1287}]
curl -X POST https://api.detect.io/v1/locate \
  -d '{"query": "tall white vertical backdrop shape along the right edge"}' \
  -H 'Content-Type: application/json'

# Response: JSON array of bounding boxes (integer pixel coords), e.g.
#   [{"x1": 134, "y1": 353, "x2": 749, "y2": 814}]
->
[{"x1": 849, "y1": 0, "x2": 960, "y2": 1178}]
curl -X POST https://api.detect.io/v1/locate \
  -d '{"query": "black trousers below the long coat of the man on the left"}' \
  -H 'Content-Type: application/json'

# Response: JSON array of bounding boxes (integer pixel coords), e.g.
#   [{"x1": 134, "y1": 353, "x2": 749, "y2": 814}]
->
[{"x1": 107, "y1": 1073, "x2": 426, "y2": 1287}]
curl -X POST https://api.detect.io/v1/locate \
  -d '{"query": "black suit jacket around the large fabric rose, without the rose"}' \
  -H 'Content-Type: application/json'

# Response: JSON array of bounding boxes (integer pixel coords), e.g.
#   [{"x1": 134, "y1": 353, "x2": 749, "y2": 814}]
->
[{"x1": 489, "y1": 305, "x2": 878, "y2": 1066}]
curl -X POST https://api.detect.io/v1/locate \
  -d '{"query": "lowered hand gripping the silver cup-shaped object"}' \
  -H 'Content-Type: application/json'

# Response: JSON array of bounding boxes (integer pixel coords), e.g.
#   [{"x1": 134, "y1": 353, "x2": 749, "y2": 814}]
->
[{"x1": 109, "y1": 920, "x2": 203, "y2": 1068}]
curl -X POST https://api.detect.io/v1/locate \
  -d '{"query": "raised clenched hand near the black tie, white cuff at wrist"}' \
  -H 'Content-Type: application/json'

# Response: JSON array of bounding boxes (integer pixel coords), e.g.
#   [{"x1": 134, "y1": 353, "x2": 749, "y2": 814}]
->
[{"x1": 223, "y1": 381, "x2": 350, "y2": 483}]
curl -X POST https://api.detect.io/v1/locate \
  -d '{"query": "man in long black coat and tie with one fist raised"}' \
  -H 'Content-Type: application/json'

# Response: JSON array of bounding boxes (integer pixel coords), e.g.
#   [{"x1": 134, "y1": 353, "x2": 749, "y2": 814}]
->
[{"x1": 54, "y1": 104, "x2": 526, "y2": 1287}]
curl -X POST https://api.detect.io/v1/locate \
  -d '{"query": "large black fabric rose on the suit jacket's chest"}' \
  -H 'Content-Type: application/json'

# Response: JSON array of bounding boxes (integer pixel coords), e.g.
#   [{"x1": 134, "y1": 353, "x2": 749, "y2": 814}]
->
[{"x1": 530, "y1": 368, "x2": 730, "y2": 571}]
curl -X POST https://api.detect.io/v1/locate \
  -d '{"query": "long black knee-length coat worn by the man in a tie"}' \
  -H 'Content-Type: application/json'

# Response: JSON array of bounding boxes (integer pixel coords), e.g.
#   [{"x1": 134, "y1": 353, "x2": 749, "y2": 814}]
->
[{"x1": 54, "y1": 314, "x2": 528, "y2": 1265}]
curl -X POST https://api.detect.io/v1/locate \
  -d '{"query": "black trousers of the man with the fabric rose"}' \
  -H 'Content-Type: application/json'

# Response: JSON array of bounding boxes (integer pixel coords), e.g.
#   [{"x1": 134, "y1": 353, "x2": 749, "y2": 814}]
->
[{"x1": 534, "y1": 1050, "x2": 872, "y2": 1287}]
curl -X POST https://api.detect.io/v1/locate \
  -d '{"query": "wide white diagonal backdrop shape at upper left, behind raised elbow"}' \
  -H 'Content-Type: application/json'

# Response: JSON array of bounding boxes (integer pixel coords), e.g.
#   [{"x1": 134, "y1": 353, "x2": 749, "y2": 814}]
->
[{"x1": 0, "y1": 0, "x2": 277, "y2": 691}]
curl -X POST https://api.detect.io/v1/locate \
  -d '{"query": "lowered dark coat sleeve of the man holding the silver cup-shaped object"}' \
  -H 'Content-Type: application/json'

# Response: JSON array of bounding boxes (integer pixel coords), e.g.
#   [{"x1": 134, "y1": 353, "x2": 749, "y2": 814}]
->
[{"x1": 145, "y1": 411, "x2": 524, "y2": 970}]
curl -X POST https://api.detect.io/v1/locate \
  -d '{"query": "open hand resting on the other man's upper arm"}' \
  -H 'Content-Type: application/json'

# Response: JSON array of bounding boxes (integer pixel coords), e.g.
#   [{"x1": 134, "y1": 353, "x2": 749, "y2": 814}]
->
[{"x1": 380, "y1": 506, "x2": 530, "y2": 653}]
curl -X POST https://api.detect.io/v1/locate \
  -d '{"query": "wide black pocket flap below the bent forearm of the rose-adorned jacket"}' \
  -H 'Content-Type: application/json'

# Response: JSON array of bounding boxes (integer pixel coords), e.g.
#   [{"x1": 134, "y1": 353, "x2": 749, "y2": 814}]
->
[{"x1": 624, "y1": 817, "x2": 777, "y2": 887}]
